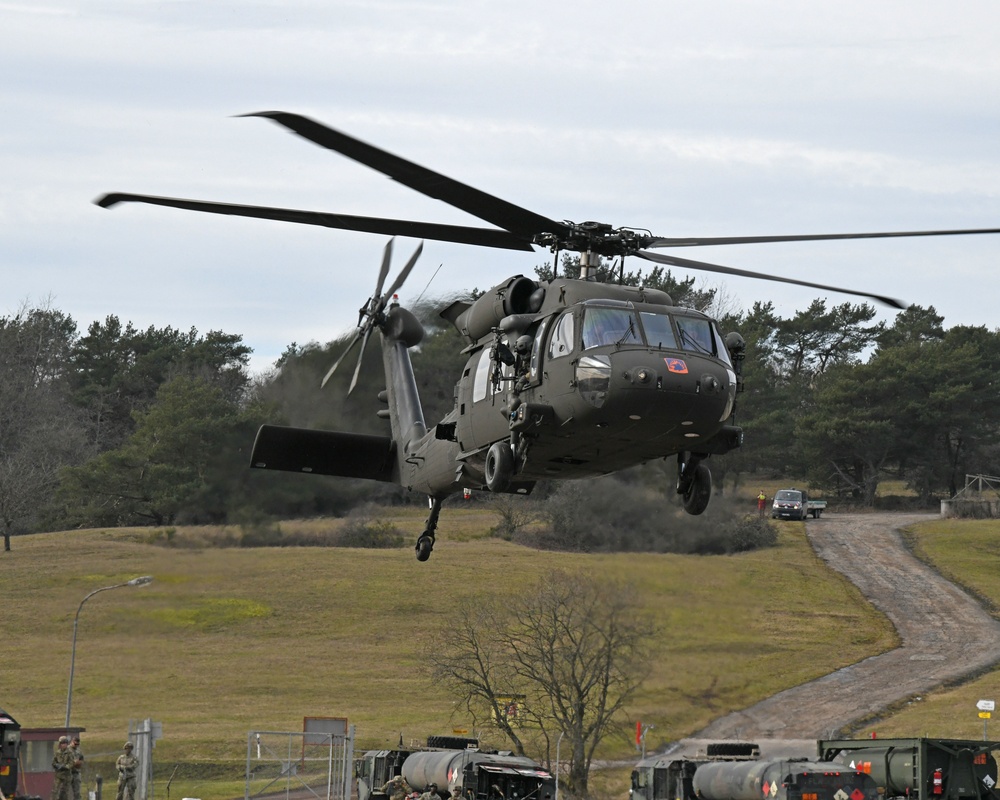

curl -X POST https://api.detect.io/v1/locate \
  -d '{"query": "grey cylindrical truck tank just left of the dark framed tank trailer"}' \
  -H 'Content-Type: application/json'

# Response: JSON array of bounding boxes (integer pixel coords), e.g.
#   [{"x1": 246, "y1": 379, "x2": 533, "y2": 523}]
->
[{"x1": 692, "y1": 760, "x2": 879, "y2": 800}]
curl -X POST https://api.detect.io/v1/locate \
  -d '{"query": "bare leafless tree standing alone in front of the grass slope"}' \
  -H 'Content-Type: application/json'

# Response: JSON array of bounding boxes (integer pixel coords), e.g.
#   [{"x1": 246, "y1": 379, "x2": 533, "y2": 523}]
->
[{"x1": 430, "y1": 572, "x2": 655, "y2": 796}]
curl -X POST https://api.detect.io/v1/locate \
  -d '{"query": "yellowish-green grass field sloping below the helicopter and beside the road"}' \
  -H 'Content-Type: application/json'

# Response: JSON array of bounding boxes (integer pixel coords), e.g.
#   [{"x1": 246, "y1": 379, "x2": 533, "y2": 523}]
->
[{"x1": 0, "y1": 509, "x2": 1000, "y2": 798}]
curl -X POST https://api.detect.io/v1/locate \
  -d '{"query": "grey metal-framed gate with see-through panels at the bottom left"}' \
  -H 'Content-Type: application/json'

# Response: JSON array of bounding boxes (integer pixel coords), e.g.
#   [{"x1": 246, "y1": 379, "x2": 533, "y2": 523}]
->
[{"x1": 244, "y1": 725, "x2": 354, "y2": 800}]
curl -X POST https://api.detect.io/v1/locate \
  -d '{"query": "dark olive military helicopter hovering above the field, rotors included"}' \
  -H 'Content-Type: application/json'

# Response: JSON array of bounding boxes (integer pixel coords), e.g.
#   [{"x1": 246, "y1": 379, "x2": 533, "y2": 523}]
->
[{"x1": 95, "y1": 111, "x2": 1000, "y2": 561}]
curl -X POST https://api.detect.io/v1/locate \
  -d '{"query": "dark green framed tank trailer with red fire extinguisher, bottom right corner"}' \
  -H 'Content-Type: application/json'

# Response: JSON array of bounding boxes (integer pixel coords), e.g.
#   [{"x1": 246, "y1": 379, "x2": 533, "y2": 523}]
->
[{"x1": 817, "y1": 738, "x2": 1000, "y2": 800}]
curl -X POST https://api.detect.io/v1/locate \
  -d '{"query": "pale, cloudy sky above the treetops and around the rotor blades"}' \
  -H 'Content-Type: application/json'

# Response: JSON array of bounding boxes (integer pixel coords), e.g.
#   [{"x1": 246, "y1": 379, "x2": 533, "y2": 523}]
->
[{"x1": 0, "y1": 0, "x2": 1000, "y2": 371}]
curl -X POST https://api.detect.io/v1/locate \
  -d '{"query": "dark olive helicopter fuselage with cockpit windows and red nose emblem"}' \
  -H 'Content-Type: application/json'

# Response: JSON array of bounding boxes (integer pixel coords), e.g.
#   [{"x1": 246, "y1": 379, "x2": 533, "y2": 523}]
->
[{"x1": 390, "y1": 276, "x2": 742, "y2": 496}]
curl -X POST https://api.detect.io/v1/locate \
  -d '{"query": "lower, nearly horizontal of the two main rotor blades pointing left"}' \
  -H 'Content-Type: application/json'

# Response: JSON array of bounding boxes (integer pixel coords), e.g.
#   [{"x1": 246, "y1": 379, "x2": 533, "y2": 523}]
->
[{"x1": 94, "y1": 192, "x2": 534, "y2": 252}]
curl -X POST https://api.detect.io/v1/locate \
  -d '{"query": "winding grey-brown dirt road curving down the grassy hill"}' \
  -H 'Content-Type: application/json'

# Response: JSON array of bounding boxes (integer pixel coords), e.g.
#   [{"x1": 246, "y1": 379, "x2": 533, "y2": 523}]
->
[{"x1": 697, "y1": 514, "x2": 1000, "y2": 741}]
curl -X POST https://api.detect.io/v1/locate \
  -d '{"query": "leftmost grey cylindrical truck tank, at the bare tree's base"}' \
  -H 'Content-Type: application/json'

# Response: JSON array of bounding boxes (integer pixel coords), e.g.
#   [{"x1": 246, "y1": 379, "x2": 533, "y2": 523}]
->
[{"x1": 402, "y1": 750, "x2": 556, "y2": 800}]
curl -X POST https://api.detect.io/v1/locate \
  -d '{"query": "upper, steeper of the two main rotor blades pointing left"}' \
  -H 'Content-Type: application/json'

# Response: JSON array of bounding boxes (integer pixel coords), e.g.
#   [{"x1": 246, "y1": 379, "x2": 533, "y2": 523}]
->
[{"x1": 241, "y1": 111, "x2": 568, "y2": 241}]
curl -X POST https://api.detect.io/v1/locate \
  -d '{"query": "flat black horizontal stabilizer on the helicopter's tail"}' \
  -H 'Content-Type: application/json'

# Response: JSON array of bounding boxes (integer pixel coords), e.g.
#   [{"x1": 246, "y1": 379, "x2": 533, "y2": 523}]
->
[{"x1": 250, "y1": 425, "x2": 395, "y2": 483}]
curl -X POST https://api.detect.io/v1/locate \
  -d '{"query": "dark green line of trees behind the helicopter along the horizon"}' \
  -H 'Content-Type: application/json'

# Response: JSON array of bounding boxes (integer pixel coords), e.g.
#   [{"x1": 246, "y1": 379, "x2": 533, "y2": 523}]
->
[{"x1": 0, "y1": 274, "x2": 1000, "y2": 549}]
